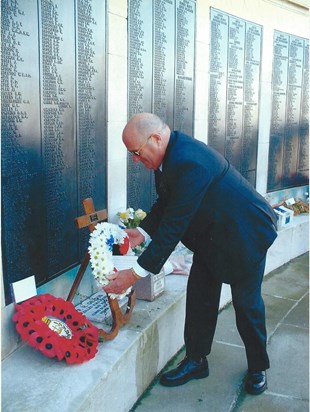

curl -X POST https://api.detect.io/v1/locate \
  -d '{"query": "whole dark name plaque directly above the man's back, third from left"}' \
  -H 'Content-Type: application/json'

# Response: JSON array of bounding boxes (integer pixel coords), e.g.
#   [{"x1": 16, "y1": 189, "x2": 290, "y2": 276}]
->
[{"x1": 208, "y1": 8, "x2": 262, "y2": 186}]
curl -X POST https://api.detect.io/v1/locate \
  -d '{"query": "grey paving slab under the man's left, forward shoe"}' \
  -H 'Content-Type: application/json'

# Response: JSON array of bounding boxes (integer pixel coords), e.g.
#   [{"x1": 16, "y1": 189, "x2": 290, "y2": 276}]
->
[{"x1": 132, "y1": 343, "x2": 245, "y2": 412}]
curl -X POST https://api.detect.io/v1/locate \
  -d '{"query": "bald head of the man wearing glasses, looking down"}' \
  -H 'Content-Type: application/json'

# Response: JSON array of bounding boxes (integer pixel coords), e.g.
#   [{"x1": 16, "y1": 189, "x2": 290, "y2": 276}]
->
[{"x1": 122, "y1": 113, "x2": 170, "y2": 169}]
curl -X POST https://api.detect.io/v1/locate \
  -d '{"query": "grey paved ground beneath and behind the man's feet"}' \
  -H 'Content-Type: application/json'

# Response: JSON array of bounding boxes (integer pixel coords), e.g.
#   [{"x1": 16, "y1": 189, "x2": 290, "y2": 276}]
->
[{"x1": 131, "y1": 253, "x2": 309, "y2": 412}]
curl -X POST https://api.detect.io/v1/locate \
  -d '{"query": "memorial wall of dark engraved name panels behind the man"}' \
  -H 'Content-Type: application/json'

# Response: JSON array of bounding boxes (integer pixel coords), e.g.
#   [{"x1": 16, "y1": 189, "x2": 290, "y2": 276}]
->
[{"x1": 1, "y1": 0, "x2": 309, "y2": 303}]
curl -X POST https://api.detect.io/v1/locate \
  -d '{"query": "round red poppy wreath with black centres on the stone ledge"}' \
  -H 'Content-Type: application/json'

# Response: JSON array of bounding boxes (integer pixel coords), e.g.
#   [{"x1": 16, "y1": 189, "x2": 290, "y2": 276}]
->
[{"x1": 13, "y1": 294, "x2": 99, "y2": 364}]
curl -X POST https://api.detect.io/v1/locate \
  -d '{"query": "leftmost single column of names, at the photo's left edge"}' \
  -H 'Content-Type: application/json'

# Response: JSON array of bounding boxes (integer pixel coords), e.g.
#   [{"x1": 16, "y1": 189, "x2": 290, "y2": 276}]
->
[{"x1": 1, "y1": 0, "x2": 46, "y2": 301}]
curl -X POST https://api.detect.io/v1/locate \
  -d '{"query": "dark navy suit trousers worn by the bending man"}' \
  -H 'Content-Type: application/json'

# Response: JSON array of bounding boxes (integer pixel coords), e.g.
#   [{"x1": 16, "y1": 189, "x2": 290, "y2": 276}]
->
[{"x1": 184, "y1": 253, "x2": 270, "y2": 371}]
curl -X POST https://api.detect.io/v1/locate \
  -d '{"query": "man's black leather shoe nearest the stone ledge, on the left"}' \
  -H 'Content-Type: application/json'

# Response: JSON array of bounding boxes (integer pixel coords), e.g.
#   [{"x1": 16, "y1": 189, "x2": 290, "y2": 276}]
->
[{"x1": 160, "y1": 357, "x2": 209, "y2": 386}]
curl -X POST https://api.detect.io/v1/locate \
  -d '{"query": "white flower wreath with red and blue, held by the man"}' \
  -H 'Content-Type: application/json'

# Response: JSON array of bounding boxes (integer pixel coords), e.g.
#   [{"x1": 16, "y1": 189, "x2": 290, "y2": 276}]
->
[{"x1": 88, "y1": 222, "x2": 131, "y2": 299}]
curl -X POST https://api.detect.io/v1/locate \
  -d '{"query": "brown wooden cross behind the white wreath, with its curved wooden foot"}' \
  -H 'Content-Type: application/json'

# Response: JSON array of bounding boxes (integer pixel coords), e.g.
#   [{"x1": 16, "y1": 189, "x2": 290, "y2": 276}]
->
[{"x1": 67, "y1": 198, "x2": 136, "y2": 340}]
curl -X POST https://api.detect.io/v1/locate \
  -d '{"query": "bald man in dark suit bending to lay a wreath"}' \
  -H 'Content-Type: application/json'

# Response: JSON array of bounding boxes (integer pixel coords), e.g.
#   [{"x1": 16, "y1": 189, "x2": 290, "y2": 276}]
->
[{"x1": 104, "y1": 113, "x2": 277, "y2": 394}]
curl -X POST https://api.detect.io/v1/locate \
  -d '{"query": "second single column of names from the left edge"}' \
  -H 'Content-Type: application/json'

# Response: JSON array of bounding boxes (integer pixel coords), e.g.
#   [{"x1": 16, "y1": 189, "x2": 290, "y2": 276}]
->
[{"x1": 40, "y1": 0, "x2": 77, "y2": 277}]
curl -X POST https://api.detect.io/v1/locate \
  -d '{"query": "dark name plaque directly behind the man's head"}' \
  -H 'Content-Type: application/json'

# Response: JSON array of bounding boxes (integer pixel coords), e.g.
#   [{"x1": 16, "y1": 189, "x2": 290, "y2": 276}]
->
[{"x1": 127, "y1": 0, "x2": 196, "y2": 211}]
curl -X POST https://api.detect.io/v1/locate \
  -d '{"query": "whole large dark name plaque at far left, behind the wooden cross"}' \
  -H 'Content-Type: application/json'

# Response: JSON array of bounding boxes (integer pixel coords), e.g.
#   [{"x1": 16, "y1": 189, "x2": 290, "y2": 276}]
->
[{"x1": 1, "y1": 0, "x2": 106, "y2": 303}]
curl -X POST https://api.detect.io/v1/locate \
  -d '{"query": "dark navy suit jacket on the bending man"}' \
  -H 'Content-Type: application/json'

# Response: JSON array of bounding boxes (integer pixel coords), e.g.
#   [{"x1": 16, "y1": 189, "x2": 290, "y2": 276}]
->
[{"x1": 138, "y1": 131, "x2": 277, "y2": 283}]
